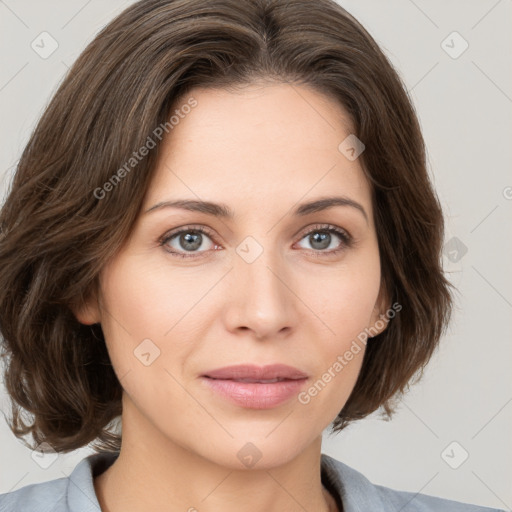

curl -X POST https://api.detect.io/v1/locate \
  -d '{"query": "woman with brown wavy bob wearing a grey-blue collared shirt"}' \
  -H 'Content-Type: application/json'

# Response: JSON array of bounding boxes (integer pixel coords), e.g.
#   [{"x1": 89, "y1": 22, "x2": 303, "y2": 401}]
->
[{"x1": 0, "y1": 0, "x2": 504, "y2": 512}]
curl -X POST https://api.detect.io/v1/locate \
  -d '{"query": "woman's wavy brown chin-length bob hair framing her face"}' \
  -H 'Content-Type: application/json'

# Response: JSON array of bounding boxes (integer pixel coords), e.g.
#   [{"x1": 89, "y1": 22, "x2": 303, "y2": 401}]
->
[{"x1": 0, "y1": 0, "x2": 452, "y2": 452}]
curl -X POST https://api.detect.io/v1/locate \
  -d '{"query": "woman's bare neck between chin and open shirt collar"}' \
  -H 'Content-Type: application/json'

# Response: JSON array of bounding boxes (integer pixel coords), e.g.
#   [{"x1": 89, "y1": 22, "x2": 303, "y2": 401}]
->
[{"x1": 94, "y1": 398, "x2": 338, "y2": 512}]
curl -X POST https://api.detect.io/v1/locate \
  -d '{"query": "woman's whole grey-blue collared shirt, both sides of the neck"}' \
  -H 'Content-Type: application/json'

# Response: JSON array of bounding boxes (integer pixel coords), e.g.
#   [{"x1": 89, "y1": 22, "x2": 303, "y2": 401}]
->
[{"x1": 0, "y1": 452, "x2": 505, "y2": 512}]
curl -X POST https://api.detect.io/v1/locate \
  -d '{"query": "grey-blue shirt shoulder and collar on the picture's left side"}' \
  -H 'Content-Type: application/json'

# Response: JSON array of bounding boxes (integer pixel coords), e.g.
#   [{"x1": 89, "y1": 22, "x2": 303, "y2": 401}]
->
[{"x1": 0, "y1": 452, "x2": 118, "y2": 512}]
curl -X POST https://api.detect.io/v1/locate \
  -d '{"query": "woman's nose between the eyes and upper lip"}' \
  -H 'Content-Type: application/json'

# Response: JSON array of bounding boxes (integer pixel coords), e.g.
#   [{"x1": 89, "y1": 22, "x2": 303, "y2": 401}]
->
[{"x1": 224, "y1": 243, "x2": 300, "y2": 340}]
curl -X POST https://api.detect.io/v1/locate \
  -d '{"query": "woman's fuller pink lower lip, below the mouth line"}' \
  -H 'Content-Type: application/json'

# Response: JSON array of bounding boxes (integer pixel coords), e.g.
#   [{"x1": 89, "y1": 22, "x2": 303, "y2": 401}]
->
[{"x1": 203, "y1": 377, "x2": 307, "y2": 409}]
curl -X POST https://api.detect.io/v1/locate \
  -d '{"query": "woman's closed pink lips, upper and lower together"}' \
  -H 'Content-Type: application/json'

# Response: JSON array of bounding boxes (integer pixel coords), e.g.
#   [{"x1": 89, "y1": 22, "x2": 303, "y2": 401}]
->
[{"x1": 201, "y1": 364, "x2": 308, "y2": 409}]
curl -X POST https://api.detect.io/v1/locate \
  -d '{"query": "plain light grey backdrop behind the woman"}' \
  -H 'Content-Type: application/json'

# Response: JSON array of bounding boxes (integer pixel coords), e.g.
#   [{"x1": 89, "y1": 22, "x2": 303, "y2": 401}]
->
[{"x1": 0, "y1": 0, "x2": 512, "y2": 510}]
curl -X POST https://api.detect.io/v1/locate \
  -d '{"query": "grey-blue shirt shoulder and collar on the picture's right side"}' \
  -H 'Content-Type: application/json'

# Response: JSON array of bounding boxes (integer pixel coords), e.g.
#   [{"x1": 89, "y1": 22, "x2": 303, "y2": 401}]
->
[{"x1": 322, "y1": 454, "x2": 505, "y2": 512}]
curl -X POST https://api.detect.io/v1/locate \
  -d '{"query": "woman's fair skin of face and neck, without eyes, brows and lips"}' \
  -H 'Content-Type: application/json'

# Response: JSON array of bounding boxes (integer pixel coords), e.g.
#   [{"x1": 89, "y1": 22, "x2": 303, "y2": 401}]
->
[{"x1": 75, "y1": 83, "x2": 389, "y2": 512}]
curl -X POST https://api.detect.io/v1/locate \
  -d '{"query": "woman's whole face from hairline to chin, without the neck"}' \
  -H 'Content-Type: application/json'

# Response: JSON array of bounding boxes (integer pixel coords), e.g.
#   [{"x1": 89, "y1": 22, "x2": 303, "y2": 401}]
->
[{"x1": 79, "y1": 84, "x2": 387, "y2": 468}]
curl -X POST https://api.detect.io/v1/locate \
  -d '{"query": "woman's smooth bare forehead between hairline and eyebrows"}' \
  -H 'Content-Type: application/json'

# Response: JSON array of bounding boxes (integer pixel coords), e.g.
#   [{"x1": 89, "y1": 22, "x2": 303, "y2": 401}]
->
[{"x1": 145, "y1": 84, "x2": 371, "y2": 218}]
